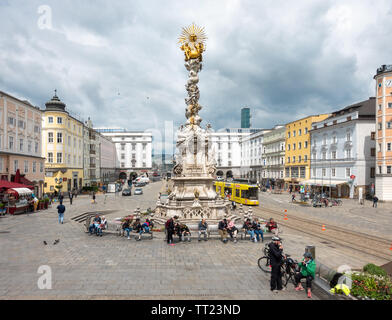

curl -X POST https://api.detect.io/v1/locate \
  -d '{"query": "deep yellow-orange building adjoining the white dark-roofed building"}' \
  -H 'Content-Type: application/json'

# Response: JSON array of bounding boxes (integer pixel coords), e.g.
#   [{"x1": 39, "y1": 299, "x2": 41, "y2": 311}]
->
[{"x1": 284, "y1": 114, "x2": 329, "y2": 190}]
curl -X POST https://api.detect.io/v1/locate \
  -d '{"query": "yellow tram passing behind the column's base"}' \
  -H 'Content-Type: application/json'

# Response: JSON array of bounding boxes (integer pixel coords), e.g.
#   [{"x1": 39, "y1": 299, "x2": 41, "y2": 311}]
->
[{"x1": 214, "y1": 181, "x2": 259, "y2": 206}]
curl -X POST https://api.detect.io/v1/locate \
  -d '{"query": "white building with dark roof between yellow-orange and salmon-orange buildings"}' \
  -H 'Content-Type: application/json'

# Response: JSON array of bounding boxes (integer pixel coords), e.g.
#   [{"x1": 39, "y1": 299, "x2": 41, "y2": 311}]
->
[{"x1": 310, "y1": 98, "x2": 376, "y2": 198}]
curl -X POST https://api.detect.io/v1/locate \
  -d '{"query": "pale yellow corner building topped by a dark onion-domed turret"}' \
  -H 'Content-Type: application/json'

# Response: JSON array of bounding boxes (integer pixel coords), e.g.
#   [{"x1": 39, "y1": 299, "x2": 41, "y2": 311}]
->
[{"x1": 42, "y1": 91, "x2": 83, "y2": 193}]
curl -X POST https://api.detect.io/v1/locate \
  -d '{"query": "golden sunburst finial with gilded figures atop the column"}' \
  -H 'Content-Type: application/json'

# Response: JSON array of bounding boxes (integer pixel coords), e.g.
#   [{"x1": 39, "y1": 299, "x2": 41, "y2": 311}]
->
[{"x1": 178, "y1": 23, "x2": 207, "y2": 61}]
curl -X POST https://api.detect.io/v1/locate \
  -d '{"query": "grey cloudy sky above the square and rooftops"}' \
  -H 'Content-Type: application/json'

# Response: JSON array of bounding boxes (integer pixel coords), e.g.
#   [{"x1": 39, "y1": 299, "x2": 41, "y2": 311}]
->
[{"x1": 0, "y1": 0, "x2": 392, "y2": 151}]
